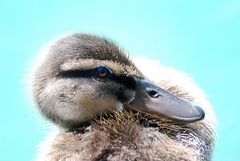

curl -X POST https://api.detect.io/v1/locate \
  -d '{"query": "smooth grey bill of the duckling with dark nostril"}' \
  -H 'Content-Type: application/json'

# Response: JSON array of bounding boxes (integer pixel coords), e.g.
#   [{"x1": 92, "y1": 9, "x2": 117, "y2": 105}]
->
[{"x1": 129, "y1": 78, "x2": 205, "y2": 122}]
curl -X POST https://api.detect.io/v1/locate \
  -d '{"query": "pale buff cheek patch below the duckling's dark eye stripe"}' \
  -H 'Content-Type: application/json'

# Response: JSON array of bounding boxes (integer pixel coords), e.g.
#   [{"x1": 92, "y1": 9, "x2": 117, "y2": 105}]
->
[{"x1": 40, "y1": 80, "x2": 123, "y2": 121}]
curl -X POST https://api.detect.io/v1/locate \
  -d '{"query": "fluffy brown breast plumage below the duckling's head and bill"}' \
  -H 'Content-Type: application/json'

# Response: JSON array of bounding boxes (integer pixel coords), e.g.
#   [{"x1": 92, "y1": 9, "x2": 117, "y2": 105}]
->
[{"x1": 36, "y1": 111, "x2": 212, "y2": 161}]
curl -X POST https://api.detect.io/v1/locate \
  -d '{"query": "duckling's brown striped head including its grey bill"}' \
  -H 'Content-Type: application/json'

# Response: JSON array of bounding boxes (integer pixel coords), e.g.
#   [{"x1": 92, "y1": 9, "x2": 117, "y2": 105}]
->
[{"x1": 33, "y1": 34, "x2": 204, "y2": 129}]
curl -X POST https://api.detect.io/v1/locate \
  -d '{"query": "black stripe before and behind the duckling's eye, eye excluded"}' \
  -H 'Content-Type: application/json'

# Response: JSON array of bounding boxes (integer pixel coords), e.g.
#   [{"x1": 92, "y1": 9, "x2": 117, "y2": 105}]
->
[{"x1": 58, "y1": 69, "x2": 136, "y2": 90}]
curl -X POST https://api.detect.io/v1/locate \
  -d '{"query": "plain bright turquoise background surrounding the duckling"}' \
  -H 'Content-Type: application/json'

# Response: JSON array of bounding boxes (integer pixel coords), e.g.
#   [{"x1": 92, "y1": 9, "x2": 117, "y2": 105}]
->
[{"x1": 0, "y1": 0, "x2": 240, "y2": 161}]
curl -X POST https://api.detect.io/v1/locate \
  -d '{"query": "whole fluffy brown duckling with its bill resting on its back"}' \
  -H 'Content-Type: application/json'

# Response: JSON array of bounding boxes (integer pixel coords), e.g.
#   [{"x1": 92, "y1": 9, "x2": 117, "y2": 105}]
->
[{"x1": 33, "y1": 33, "x2": 215, "y2": 161}]
